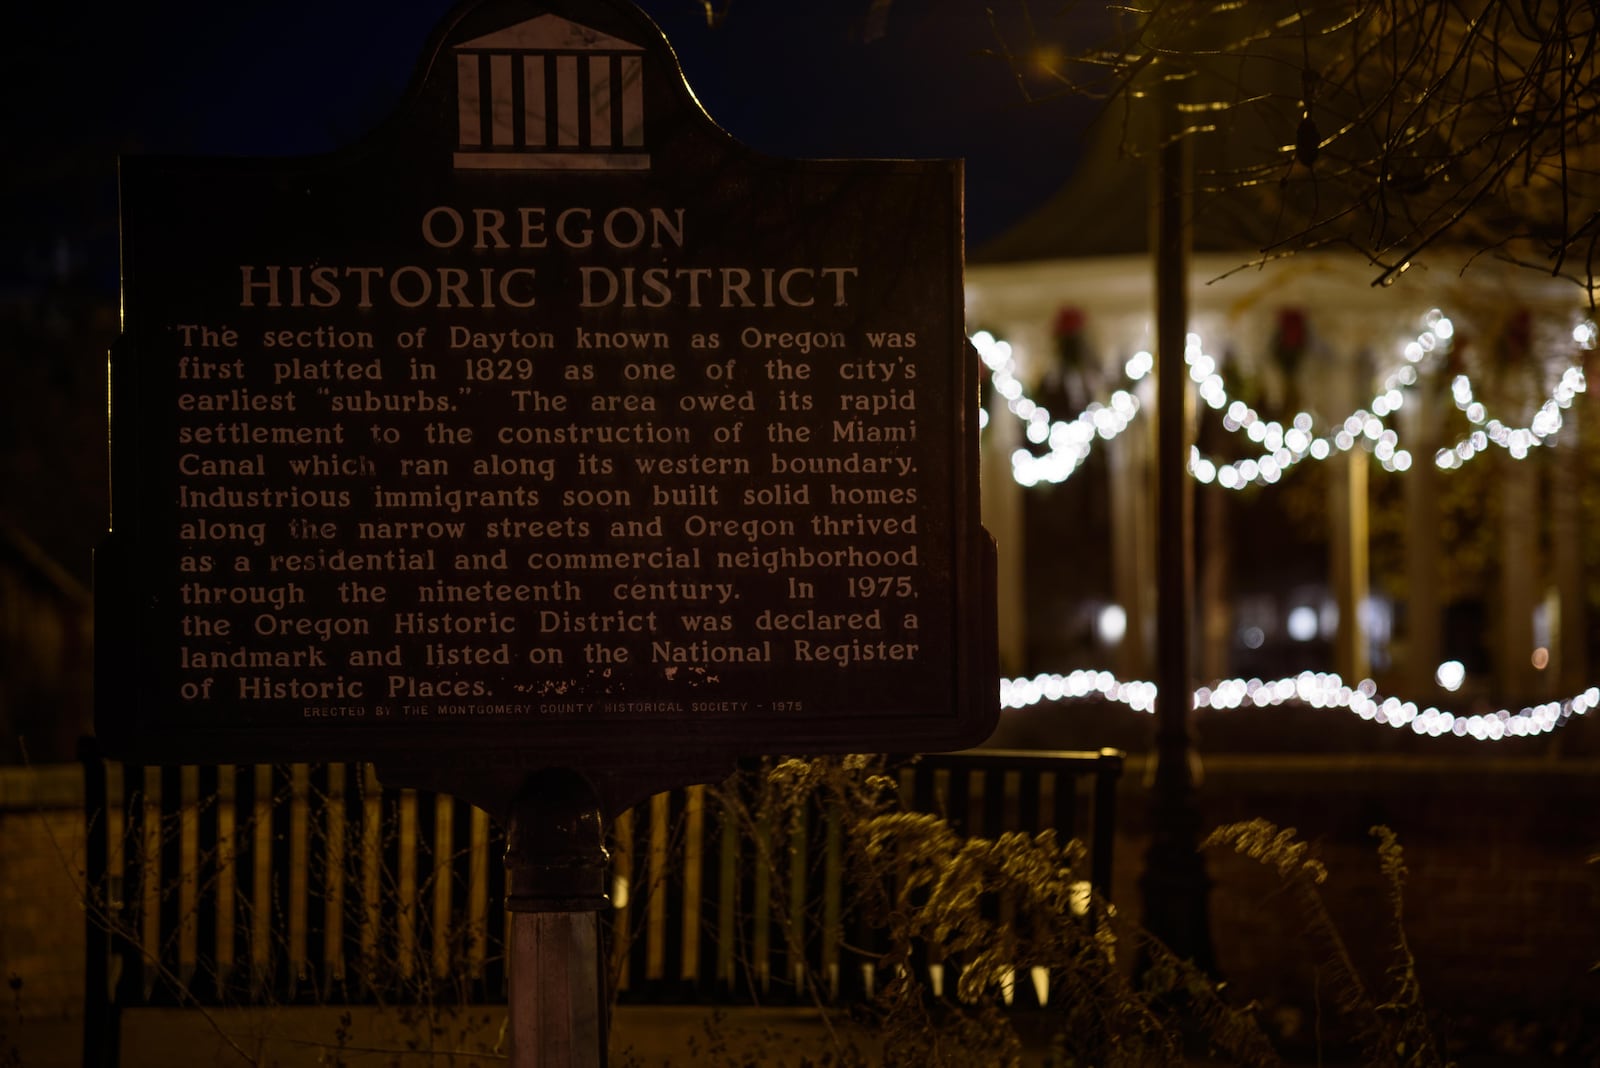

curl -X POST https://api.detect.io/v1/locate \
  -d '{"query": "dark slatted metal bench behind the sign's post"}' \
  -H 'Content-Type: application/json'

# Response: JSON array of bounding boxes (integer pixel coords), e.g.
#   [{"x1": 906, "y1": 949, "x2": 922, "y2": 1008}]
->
[{"x1": 85, "y1": 738, "x2": 1122, "y2": 1028}]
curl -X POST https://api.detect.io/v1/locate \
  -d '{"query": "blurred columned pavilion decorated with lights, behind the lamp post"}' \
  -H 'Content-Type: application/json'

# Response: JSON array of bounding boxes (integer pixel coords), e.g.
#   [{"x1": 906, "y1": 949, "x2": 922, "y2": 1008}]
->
[{"x1": 966, "y1": 137, "x2": 1600, "y2": 748}]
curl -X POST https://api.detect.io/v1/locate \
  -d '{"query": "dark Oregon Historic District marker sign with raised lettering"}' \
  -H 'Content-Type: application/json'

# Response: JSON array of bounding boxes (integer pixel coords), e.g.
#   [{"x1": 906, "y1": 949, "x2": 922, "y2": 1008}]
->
[{"x1": 98, "y1": 0, "x2": 997, "y2": 783}]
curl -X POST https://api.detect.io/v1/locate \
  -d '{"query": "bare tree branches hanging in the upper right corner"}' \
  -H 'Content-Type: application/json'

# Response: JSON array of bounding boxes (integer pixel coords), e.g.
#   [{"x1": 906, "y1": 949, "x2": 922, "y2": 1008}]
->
[{"x1": 990, "y1": 0, "x2": 1600, "y2": 307}]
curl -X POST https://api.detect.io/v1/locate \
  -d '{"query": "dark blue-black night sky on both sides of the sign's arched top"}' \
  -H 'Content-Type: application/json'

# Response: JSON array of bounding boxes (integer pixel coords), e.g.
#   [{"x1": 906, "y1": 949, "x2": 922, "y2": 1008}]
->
[{"x1": 0, "y1": 0, "x2": 1094, "y2": 288}]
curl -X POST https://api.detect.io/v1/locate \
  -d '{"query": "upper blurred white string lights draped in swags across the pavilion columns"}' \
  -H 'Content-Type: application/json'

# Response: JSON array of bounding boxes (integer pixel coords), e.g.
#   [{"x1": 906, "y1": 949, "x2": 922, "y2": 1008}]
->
[{"x1": 973, "y1": 309, "x2": 1600, "y2": 489}]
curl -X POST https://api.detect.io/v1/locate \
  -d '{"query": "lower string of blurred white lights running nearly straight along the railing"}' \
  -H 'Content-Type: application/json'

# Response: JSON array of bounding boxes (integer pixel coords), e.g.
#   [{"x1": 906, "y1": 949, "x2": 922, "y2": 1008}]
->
[{"x1": 1000, "y1": 670, "x2": 1600, "y2": 742}]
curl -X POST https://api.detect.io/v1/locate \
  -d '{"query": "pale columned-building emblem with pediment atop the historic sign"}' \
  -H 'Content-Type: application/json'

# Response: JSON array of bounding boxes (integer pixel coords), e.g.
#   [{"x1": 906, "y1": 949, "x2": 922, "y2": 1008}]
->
[{"x1": 456, "y1": 14, "x2": 650, "y2": 171}]
